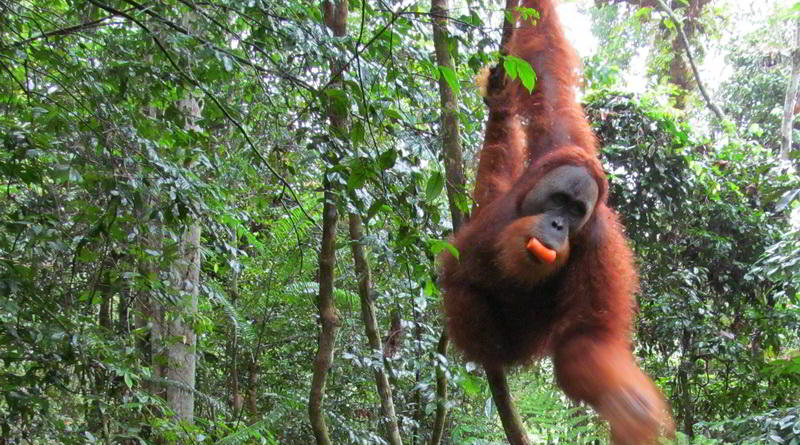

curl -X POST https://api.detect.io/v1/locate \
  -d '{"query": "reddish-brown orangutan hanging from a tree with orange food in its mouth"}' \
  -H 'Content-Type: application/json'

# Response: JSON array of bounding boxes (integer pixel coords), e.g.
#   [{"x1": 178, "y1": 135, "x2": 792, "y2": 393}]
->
[{"x1": 441, "y1": 0, "x2": 673, "y2": 445}]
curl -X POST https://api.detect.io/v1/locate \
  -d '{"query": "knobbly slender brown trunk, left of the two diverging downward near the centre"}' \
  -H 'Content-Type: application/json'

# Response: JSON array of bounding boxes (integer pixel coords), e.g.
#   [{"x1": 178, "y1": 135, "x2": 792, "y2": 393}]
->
[{"x1": 308, "y1": 185, "x2": 339, "y2": 445}]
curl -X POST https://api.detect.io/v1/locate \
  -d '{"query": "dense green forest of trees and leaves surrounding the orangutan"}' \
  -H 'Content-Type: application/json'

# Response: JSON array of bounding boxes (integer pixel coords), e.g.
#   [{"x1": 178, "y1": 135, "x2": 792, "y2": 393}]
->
[{"x1": 0, "y1": 0, "x2": 800, "y2": 445}]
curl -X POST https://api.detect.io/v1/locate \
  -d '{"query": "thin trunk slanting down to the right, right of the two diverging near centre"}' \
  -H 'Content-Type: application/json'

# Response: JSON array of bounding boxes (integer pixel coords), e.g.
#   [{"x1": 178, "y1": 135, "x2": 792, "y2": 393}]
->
[{"x1": 349, "y1": 213, "x2": 403, "y2": 445}]
